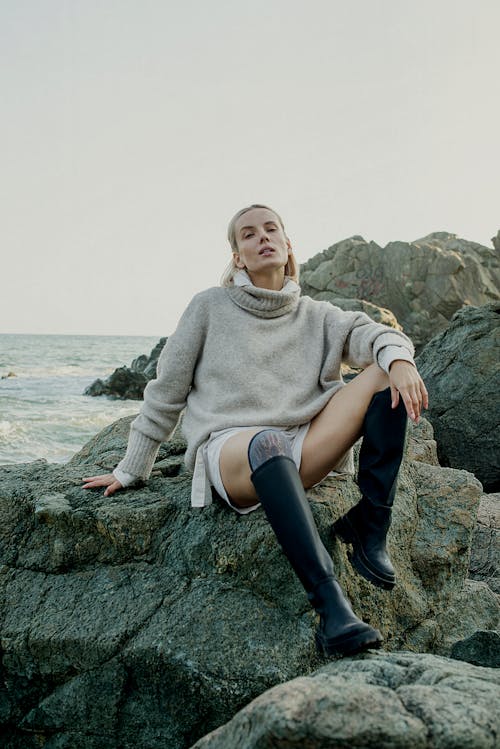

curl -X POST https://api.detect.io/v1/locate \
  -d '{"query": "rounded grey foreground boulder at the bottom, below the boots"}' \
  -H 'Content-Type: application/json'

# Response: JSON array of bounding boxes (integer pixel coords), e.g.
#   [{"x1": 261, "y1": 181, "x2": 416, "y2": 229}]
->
[{"x1": 192, "y1": 652, "x2": 500, "y2": 749}]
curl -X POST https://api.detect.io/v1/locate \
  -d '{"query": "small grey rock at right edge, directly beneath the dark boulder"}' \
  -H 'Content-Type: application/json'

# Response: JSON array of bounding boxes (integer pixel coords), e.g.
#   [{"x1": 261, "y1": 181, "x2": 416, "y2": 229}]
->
[{"x1": 469, "y1": 494, "x2": 500, "y2": 593}]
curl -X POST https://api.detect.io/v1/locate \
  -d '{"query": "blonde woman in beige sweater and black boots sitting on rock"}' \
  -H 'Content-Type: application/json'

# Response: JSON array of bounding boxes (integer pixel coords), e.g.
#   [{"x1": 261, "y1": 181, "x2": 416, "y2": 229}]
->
[{"x1": 84, "y1": 204, "x2": 428, "y2": 655}]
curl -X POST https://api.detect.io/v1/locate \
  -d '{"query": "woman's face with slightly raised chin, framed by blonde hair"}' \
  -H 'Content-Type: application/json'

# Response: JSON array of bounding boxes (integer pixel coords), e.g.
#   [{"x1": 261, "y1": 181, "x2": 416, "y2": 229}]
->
[{"x1": 233, "y1": 208, "x2": 292, "y2": 275}]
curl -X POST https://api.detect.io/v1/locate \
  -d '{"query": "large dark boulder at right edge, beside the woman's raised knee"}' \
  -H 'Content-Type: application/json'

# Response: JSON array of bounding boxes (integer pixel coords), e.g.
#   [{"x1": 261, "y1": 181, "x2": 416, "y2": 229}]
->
[{"x1": 417, "y1": 303, "x2": 500, "y2": 492}]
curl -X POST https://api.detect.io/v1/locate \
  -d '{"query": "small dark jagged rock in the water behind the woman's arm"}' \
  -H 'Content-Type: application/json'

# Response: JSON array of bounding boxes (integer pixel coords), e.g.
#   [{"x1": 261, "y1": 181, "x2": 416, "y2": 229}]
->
[{"x1": 83, "y1": 338, "x2": 167, "y2": 400}]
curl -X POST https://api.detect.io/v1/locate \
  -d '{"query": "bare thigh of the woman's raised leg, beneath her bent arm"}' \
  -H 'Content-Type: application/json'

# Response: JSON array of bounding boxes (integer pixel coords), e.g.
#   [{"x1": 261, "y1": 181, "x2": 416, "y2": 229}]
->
[{"x1": 300, "y1": 364, "x2": 389, "y2": 488}]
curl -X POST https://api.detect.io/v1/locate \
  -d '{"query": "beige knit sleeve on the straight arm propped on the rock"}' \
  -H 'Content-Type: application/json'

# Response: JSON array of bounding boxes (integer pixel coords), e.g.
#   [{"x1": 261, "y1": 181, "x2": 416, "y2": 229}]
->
[{"x1": 117, "y1": 294, "x2": 206, "y2": 479}]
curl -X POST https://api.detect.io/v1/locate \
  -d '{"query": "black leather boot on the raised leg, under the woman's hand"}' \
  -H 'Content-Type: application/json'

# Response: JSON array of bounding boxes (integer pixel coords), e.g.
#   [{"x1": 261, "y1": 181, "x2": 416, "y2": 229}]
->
[{"x1": 332, "y1": 388, "x2": 407, "y2": 590}]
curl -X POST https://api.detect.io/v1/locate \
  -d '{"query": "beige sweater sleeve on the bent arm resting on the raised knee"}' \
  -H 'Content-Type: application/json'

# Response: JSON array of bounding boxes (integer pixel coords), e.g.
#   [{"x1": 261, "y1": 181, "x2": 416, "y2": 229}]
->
[{"x1": 335, "y1": 308, "x2": 415, "y2": 368}]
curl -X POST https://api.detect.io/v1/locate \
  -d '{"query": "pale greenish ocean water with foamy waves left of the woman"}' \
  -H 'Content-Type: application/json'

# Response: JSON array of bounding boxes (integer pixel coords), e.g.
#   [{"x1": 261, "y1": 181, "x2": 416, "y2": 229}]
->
[{"x1": 0, "y1": 334, "x2": 158, "y2": 465}]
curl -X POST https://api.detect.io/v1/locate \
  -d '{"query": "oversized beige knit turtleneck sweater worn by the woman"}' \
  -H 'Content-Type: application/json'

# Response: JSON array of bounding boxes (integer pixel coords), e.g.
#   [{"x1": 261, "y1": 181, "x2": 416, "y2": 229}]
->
[{"x1": 117, "y1": 274, "x2": 413, "y2": 478}]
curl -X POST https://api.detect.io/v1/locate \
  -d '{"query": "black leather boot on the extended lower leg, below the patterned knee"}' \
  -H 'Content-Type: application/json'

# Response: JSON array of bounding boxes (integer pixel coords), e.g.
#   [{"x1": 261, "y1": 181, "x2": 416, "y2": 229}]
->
[{"x1": 252, "y1": 455, "x2": 382, "y2": 655}]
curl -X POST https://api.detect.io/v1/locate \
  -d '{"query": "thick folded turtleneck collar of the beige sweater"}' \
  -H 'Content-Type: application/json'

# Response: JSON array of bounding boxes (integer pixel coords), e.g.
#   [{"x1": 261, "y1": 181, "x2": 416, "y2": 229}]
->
[{"x1": 227, "y1": 270, "x2": 300, "y2": 317}]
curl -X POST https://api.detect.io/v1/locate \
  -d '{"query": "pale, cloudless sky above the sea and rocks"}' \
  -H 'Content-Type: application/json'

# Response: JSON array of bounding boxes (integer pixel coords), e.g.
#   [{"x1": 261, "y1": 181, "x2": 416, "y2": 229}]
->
[{"x1": 0, "y1": 0, "x2": 500, "y2": 336}]
